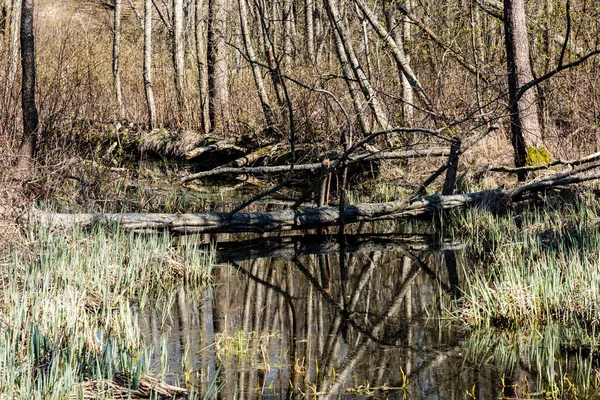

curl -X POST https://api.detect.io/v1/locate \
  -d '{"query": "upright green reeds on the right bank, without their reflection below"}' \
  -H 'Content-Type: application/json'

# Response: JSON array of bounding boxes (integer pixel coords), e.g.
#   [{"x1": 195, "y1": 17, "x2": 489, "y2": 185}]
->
[{"x1": 453, "y1": 199, "x2": 600, "y2": 327}]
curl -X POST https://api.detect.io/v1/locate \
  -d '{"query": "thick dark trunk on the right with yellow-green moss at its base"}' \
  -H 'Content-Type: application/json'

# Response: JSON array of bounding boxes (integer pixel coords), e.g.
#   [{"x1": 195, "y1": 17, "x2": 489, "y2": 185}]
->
[{"x1": 504, "y1": 0, "x2": 542, "y2": 173}]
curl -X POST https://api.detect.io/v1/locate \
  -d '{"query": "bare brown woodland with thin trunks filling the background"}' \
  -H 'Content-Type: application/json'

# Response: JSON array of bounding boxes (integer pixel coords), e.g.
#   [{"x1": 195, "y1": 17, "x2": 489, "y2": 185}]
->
[{"x1": 0, "y1": 0, "x2": 600, "y2": 220}]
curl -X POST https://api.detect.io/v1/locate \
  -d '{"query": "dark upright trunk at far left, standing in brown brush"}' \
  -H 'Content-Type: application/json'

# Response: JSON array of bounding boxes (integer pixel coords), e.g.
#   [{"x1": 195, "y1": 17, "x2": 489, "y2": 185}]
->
[{"x1": 17, "y1": 0, "x2": 39, "y2": 173}]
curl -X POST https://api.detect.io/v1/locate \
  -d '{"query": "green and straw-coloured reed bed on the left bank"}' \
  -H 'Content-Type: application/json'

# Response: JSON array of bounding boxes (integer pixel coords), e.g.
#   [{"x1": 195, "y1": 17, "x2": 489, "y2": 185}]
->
[{"x1": 0, "y1": 225, "x2": 212, "y2": 399}]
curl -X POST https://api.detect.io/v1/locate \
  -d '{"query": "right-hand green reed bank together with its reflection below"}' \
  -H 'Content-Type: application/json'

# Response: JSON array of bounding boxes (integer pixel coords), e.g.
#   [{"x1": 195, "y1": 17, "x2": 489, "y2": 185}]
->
[{"x1": 443, "y1": 195, "x2": 600, "y2": 398}]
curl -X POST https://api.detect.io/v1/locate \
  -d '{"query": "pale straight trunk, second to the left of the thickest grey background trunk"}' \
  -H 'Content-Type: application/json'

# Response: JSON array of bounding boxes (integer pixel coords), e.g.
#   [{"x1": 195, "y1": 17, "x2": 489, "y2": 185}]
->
[{"x1": 173, "y1": 0, "x2": 185, "y2": 123}]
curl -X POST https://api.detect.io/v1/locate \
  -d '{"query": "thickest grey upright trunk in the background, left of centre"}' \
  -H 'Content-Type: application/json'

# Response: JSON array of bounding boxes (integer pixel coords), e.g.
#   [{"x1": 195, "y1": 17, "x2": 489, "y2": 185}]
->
[{"x1": 208, "y1": 0, "x2": 229, "y2": 134}]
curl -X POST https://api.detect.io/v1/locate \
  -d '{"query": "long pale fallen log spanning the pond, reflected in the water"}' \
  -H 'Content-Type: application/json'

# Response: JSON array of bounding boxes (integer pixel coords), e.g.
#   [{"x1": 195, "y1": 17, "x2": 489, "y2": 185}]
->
[{"x1": 29, "y1": 191, "x2": 492, "y2": 234}]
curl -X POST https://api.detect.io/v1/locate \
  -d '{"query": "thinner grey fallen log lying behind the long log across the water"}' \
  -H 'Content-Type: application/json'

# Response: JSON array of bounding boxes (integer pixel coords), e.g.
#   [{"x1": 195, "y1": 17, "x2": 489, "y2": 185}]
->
[{"x1": 181, "y1": 148, "x2": 450, "y2": 183}]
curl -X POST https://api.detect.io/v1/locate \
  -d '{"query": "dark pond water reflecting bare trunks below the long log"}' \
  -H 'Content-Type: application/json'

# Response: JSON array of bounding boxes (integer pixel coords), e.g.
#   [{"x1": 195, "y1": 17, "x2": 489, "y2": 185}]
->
[{"x1": 140, "y1": 230, "x2": 600, "y2": 399}]
